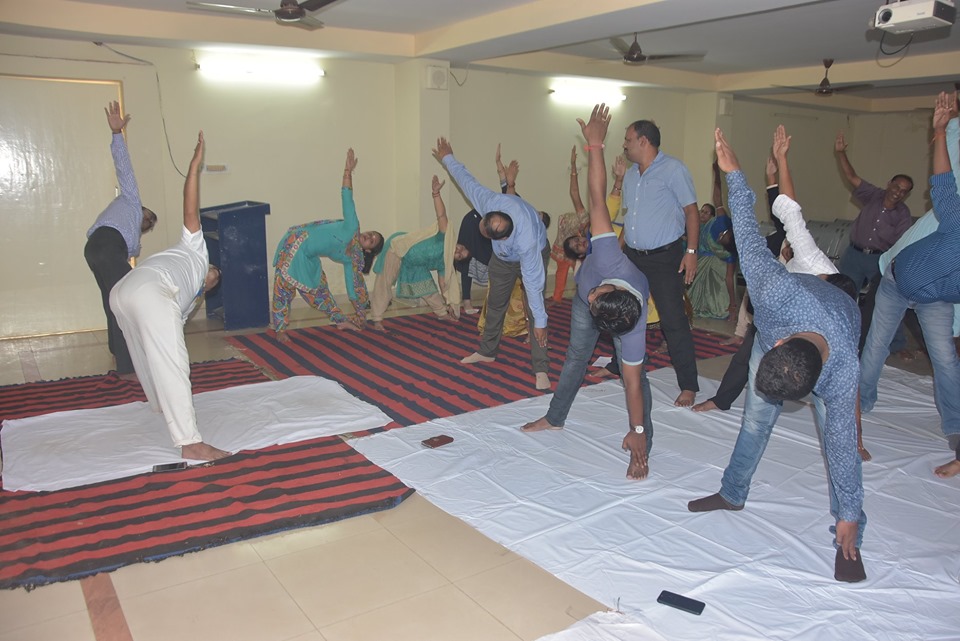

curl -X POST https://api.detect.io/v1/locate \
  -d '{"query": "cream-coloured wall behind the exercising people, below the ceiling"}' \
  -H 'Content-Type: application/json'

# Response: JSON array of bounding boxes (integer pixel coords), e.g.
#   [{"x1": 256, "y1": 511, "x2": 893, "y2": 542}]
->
[{"x1": 0, "y1": 36, "x2": 929, "y2": 336}]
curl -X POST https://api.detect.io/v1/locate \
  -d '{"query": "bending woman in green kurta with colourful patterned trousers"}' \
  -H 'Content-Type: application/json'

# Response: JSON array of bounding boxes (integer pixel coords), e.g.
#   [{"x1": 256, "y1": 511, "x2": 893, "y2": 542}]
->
[{"x1": 272, "y1": 149, "x2": 383, "y2": 343}]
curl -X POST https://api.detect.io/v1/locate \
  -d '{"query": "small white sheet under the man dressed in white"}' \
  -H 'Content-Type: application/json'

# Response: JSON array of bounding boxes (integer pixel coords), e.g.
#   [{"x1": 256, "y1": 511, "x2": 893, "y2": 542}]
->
[{"x1": 0, "y1": 376, "x2": 391, "y2": 490}]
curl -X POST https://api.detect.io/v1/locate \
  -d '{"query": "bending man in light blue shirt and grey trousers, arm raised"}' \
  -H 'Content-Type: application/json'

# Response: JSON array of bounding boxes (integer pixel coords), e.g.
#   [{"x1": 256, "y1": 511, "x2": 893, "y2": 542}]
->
[{"x1": 433, "y1": 138, "x2": 550, "y2": 390}]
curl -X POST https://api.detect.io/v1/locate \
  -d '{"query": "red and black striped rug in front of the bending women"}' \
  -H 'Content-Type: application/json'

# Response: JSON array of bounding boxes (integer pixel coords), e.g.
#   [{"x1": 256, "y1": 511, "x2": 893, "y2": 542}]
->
[{"x1": 228, "y1": 300, "x2": 736, "y2": 428}]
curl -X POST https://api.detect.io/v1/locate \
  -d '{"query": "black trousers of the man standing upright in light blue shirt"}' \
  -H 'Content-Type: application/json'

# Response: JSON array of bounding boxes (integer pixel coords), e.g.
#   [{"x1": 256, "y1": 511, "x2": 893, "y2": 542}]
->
[{"x1": 624, "y1": 239, "x2": 700, "y2": 392}]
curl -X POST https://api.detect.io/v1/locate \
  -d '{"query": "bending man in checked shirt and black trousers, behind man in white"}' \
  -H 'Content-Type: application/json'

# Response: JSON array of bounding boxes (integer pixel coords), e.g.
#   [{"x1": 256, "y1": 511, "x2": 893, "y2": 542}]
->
[{"x1": 83, "y1": 101, "x2": 157, "y2": 379}]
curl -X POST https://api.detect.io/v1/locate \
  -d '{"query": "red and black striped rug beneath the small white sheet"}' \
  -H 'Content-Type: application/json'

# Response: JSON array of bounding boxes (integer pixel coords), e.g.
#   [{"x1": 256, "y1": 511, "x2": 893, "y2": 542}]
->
[{"x1": 0, "y1": 360, "x2": 413, "y2": 588}]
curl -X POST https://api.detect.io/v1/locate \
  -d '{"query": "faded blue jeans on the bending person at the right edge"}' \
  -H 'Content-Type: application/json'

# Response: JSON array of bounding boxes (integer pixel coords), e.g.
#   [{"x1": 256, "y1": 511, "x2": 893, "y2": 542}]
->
[{"x1": 860, "y1": 263, "x2": 960, "y2": 436}]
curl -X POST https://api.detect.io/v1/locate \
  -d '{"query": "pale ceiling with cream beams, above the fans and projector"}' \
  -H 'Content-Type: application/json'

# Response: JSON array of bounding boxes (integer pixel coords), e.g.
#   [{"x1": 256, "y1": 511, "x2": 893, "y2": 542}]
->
[{"x1": 0, "y1": 0, "x2": 960, "y2": 100}]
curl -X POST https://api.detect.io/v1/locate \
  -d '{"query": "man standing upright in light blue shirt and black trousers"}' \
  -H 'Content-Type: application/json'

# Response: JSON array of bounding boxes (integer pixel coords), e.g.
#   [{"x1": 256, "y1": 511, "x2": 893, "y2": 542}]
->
[{"x1": 623, "y1": 120, "x2": 700, "y2": 407}]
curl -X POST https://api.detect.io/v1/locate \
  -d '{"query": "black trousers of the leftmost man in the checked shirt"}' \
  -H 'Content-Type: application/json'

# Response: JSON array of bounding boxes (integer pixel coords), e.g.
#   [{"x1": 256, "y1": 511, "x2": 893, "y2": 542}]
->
[{"x1": 83, "y1": 227, "x2": 133, "y2": 374}]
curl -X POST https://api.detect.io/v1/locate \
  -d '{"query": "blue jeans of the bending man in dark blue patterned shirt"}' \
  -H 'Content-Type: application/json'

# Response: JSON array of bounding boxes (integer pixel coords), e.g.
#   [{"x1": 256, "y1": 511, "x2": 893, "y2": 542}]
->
[{"x1": 720, "y1": 340, "x2": 867, "y2": 547}]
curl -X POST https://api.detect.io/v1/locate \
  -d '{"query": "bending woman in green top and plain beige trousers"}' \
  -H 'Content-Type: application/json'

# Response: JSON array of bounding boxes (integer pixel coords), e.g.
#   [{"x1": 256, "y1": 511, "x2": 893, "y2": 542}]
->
[{"x1": 370, "y1": 176, "x2": 469, "y2": 331}]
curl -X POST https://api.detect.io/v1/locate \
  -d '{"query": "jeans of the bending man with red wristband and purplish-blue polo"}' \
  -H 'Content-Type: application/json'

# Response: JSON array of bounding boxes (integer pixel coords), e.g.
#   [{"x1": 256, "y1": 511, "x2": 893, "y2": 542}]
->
[{"x1": 546, "y1": 294, "x2": 653, "y2": 453}]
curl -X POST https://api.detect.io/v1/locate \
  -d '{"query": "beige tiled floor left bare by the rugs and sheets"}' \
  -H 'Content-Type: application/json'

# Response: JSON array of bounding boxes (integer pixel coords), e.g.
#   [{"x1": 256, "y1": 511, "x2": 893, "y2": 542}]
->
[{"x1": 0, "y1": 294, "x2": 929, "y2": 641}]
